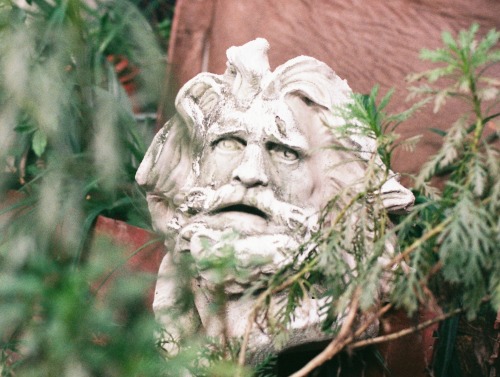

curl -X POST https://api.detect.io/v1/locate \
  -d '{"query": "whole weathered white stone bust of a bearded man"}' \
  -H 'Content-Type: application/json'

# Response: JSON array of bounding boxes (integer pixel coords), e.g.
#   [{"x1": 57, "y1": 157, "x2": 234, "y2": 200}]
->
[{"x1": 136, "y1": 39, "x2": 413, "y2": 358}]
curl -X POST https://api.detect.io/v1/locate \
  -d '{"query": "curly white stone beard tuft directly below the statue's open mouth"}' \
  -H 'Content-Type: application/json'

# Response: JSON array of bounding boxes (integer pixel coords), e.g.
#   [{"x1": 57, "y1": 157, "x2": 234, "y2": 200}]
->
[{"x1": 178, "y1": 217, "x2": 305, "y2": 282}]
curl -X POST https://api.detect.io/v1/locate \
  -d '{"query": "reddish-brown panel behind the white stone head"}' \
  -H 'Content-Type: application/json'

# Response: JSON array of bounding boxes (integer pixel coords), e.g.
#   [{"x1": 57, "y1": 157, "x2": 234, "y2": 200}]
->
[{"x1": 160, "y1": 0, "x2": 500, "y2": 377}]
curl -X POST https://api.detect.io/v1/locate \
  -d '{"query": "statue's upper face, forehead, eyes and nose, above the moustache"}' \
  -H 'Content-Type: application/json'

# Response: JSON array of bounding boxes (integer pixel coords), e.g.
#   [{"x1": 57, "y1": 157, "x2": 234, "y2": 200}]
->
[{"x1": 199, "y1": 97, "x2": 314, "y2": 204}]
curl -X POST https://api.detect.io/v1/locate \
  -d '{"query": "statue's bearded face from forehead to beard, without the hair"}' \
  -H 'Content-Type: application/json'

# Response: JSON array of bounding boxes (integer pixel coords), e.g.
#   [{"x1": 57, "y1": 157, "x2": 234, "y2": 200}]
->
[{"x1": 174, "y1": 96, "x2": 324, "y2": 300}]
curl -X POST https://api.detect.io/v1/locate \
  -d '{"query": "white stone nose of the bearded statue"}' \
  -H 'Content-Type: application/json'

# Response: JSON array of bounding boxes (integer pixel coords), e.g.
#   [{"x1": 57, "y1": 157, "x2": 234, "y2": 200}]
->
[{"x1": 232, "y1": 145, "x2": 269, "y2": 188}]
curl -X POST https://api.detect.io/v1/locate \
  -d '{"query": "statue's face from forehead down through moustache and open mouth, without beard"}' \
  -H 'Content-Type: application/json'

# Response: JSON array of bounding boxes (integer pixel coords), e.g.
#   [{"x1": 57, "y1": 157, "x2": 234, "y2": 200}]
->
[{"x1": 186, "y1": 97, "x2": 319, "y2": 234}]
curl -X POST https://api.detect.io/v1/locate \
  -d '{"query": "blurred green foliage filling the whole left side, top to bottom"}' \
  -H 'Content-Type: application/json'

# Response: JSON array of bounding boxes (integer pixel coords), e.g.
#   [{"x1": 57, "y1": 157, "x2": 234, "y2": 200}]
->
[{"x1": 0, "y1": 0, "x2": 174, "y2": 376}]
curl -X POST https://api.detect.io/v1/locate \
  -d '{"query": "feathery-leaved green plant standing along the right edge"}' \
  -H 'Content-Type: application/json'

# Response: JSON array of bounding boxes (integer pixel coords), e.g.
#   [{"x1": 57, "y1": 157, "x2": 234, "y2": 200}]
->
[{"x1": 403, "y1": 25, "x2": 500, "y2": 317}]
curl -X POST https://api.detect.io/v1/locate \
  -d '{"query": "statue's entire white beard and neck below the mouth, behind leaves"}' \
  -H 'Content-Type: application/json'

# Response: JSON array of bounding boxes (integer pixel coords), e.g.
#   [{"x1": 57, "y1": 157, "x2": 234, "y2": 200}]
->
[{"x1": 168, "y1": 212, "x2": 352, "y2": 363}]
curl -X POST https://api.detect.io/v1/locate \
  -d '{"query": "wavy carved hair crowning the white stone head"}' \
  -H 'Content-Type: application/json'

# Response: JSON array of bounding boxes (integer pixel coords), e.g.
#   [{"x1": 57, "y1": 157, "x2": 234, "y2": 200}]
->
[{"x1": 136, "y1": 38, "x2": 412, "y2": 232}]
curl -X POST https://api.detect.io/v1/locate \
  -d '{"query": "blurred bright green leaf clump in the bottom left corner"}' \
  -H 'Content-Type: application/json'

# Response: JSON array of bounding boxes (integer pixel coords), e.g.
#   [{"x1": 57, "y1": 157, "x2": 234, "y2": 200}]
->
[{"x1": 0, "y1": 229, "x2": 165, "y2": 376}]
